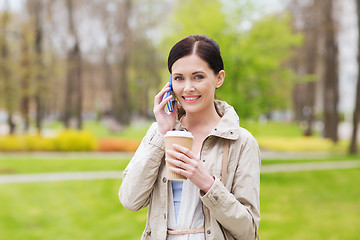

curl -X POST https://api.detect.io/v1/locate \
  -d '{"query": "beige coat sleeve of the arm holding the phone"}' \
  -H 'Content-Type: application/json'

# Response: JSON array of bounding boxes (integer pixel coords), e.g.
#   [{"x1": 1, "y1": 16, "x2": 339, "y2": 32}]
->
[{"x1": 119, "y1": 123, "x2": 165, "y2": 211}]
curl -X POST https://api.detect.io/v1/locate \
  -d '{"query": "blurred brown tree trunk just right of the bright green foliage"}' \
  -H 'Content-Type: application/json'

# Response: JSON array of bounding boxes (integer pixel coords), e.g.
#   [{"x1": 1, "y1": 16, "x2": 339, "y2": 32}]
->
[{"x1": 288, "y1": 0, "x2": 322, "y2": 136}]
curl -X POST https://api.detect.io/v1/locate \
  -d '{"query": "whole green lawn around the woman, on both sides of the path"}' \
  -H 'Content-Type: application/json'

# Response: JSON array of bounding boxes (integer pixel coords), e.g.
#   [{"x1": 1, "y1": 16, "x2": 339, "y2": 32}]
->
[{"x1": 0, "y1": 155, "x2": 360, "y2": 240}]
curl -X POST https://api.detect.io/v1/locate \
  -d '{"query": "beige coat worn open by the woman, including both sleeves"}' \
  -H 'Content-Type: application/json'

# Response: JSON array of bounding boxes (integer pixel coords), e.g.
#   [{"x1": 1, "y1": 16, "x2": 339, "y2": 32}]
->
[{"x1": 119, "y1": 101, "x2": 261, "y2": 240}]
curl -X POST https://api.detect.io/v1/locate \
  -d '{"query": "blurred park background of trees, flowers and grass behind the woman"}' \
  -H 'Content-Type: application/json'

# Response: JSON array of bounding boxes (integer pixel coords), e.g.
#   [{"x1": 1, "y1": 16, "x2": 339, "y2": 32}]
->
[{"x1": 0, "y1": 0, "x2": 360, "y2": 239}]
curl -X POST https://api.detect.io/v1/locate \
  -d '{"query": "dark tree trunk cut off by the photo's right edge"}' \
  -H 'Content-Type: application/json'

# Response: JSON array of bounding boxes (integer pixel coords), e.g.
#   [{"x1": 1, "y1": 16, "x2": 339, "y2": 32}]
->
[{"x1": 349, "y1": 0, "x2": 360, "y2": 154}]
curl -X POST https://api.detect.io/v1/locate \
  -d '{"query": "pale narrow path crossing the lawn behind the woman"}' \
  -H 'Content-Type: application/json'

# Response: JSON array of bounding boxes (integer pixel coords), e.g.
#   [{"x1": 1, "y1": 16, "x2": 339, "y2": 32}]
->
[{"x1": 0, "y1": 160, "x2": 360, "y2": 184}]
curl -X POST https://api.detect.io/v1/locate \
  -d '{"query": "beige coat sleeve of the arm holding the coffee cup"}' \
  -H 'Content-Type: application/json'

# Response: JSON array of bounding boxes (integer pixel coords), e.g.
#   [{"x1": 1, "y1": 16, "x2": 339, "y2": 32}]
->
[{"x1": 201, "y1": 132, "x2": 261, "y2": 239}]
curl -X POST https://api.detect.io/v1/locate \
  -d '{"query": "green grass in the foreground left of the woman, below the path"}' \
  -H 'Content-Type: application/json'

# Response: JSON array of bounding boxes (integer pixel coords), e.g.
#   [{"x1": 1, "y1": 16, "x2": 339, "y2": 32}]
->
[{"x1": 0, "y1": 180, "x2": 146, "y2": 240}]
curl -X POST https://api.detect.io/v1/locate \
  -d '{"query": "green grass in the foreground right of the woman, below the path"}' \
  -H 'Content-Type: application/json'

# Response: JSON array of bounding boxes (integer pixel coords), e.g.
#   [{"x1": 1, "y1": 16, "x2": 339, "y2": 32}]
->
[{"x1": 260, "y1": 169, "x2": 360, "y2": 240}]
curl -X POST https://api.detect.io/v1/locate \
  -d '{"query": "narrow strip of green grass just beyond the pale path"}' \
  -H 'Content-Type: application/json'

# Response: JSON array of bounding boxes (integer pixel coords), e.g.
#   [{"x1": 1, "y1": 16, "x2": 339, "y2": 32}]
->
[{"x1": 0, "y1": 154, "x2": 360, "y2": 175}]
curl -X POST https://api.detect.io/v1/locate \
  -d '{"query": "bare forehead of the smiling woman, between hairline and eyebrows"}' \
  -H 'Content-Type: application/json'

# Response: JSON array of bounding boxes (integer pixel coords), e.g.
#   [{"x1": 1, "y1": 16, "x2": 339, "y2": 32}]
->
[{"x1": 172, "y1": 54, "x2": 212, "y2": 74}]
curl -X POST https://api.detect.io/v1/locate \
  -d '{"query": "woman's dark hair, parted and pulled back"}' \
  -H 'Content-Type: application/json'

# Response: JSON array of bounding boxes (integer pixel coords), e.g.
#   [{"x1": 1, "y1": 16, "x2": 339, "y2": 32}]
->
[{"x1": 168, "y1": 35, "x2": 224, "y2": 74}]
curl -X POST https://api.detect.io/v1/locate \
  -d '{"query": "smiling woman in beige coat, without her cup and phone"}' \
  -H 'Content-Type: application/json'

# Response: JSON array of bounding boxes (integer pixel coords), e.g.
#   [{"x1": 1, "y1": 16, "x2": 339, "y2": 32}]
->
[{"x1": 119, "y1": 35, "x2": 260, "y2": 240}]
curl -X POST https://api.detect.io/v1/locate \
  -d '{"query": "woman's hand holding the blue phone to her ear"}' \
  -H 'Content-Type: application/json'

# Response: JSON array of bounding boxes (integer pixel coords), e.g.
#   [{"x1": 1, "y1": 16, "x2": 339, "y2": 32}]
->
[{"x1": 153, "y1": 82, "x2": 177, "y2": 135}]
